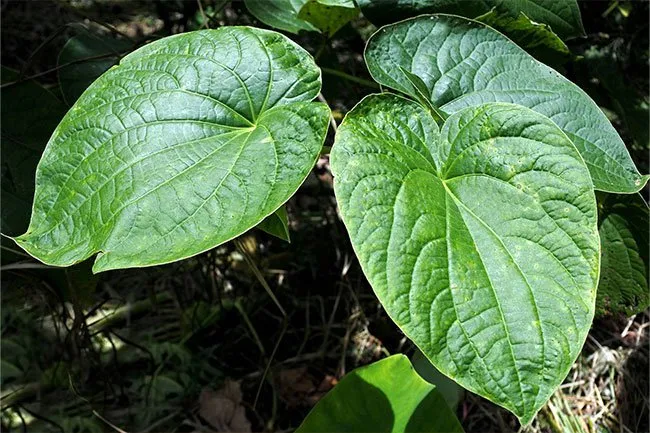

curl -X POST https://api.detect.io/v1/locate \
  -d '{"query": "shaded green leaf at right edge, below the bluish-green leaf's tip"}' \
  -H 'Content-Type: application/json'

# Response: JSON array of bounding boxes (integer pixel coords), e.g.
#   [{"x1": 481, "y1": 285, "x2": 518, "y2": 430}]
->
[{"x1": 596, "y1": 194, "x2": 650, "y2": 315}]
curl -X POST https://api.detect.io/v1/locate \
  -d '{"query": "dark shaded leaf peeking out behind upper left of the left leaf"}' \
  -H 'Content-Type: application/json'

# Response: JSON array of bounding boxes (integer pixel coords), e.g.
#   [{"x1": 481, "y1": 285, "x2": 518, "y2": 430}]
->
[{"x1": 58, "y1": 30, "x2": 133, "y2": 105}]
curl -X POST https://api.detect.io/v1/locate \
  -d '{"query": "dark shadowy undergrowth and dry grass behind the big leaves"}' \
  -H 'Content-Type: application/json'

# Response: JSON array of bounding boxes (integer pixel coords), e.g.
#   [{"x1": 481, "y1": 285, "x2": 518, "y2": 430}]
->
[{"x1": 0, "y1": 0, "x2": 650, "y2": 432}]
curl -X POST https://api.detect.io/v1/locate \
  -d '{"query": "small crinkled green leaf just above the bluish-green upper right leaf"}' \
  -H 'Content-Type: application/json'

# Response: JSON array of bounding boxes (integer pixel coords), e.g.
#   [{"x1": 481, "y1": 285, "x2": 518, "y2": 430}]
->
[{"x1": 476, "y1": 10, "x2": 571, "y2": 65}]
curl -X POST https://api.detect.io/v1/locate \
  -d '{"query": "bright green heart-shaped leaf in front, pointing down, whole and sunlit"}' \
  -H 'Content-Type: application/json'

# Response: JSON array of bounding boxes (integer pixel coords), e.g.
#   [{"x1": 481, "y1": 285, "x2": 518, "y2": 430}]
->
[{"x1": 331, "y1": 94, "x2": 599, "y2": 424}]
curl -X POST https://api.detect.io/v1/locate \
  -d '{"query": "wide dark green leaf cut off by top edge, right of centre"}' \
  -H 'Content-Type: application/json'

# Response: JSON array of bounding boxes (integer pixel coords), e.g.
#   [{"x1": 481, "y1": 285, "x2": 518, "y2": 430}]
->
[{"x1": 357, "y1": 0, "x2": 584, "y2": 38}]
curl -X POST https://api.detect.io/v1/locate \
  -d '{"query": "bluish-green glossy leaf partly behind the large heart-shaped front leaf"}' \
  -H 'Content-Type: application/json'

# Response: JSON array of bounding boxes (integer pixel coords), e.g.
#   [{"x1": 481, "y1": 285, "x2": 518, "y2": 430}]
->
[{"x1": 365, "y1": 15, "x2": 648, "y2": 193}]
